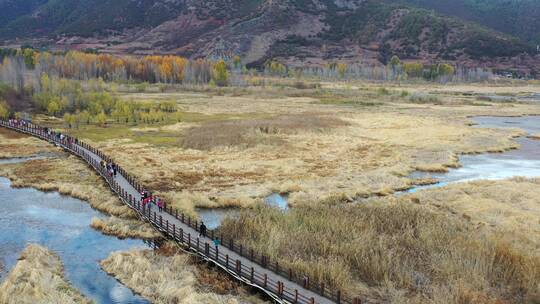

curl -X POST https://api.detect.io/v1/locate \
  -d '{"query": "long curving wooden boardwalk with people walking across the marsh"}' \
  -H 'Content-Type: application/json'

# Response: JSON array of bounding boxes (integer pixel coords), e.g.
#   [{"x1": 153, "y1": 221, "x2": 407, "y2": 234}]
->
[{"x1": 0, "y1": 120, "x2": 360, "y2": 304}]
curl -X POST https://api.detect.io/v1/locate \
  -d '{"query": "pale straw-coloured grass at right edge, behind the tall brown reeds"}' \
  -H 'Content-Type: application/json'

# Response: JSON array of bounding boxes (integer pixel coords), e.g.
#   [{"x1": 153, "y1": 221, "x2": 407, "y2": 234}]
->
[{"x1": 402, "y1": 177, "x2": 540, "y2": 252}]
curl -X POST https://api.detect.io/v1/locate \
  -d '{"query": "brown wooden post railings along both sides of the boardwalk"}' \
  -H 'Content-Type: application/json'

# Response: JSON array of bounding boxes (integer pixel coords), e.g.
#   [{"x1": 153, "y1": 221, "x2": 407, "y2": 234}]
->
[{"x1": 0, "y1": 120, "x2": 361, "y2": 304}]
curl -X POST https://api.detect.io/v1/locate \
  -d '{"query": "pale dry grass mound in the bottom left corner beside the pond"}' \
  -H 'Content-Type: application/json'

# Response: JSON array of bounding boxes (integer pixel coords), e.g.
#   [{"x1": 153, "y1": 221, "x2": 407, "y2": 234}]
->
[{"x1": 0, "y1": 244, "x2": 92, "y2": 304}]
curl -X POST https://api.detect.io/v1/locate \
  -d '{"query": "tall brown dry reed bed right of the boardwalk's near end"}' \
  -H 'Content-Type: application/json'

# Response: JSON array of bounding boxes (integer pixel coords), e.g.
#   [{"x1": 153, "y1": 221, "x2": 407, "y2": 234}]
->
[{"x1": 222, "y1": 201, "x2": 540, "y2": 304}]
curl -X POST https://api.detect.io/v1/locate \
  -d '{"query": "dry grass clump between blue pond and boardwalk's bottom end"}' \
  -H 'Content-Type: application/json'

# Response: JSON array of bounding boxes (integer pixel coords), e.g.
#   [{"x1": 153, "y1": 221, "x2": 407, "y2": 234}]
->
[{"x1": 101, "y1": 243, "x2": 264, "y2": 304}]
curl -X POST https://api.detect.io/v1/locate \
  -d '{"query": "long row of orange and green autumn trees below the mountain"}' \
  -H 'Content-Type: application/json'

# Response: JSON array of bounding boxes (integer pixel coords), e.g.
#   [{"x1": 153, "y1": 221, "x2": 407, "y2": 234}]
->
[{"x1": 0, "y1": 48, "x2": 493, "y2": 89}]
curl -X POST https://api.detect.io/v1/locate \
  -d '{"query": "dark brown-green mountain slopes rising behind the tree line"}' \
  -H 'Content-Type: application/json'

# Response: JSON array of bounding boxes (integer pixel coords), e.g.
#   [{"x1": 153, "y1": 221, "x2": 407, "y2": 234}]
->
[{"x1": 0, "y1": 0, "x2": 540, "y2": 71}]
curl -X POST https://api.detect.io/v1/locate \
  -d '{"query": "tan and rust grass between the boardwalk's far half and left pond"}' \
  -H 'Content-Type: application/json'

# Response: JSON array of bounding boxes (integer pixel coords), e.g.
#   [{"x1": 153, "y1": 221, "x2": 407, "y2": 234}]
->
[{"x1": 0, "y1": 130, "x2": 157, "y2": 239}]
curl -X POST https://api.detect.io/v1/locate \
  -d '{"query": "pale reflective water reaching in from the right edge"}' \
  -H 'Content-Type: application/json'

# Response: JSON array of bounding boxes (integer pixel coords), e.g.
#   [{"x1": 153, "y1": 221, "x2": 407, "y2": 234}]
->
[{"x1": 406, "y1": 116, "x2": 540, "y2": 193}]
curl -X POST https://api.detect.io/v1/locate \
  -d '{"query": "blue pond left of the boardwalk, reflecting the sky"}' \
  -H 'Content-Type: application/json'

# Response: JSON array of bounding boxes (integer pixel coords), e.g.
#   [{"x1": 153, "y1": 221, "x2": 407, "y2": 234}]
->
[{"x1": 0, "y1": 177, "x2": 149, "y2": 304}]
